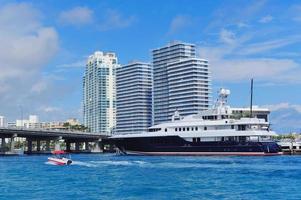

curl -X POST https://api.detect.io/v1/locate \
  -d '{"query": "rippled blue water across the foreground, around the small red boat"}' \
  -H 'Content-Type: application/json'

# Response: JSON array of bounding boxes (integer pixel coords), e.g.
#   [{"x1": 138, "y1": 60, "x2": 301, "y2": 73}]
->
[{"x1": 0, "y1": 154, "x2": 301, "y2": 200}]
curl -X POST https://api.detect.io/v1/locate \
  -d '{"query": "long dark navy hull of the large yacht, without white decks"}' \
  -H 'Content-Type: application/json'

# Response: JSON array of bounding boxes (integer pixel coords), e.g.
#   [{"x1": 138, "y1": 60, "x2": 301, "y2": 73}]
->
[{"x1": 110, "y1": 136, "x2": 282, "y2": 156}]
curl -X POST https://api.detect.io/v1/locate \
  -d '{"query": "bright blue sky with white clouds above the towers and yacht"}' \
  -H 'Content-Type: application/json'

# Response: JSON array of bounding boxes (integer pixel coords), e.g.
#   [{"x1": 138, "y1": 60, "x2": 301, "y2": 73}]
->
[{"x1": 0, "y1": 0, "x2": 301, "y2": 132}]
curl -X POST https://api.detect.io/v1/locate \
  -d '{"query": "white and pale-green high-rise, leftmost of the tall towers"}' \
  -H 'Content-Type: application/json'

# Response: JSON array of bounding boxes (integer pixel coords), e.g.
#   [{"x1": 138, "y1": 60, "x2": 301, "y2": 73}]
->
[{"x1": 83, "y1": 51, "x2": 118, "y2": 135}]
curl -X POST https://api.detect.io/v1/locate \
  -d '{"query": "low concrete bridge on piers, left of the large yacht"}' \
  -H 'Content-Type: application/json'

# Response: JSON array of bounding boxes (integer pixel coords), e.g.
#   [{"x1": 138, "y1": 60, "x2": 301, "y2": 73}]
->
[{"x1": 0, "y1": 128, "x2": 107, "y2": 155}]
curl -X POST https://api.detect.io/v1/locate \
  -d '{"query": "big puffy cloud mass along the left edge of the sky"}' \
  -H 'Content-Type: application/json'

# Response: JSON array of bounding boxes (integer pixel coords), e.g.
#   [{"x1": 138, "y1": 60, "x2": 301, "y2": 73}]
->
[{"x1": 0, "y1": 3, "x2": 59, "y2": 121}]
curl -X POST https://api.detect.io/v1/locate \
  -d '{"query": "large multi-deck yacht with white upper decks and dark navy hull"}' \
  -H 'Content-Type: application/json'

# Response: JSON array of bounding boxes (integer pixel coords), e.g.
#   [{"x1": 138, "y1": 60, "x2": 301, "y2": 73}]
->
[{"x1": 108, "y1": 89, "x2": 282, "y2": 156}]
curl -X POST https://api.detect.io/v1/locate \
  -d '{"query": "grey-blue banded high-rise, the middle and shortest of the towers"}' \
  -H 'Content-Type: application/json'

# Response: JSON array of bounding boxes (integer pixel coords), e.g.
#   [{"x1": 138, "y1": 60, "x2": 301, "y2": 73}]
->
[{"x1": 116, "y1": 62, "x2": 152, "y2": 134}]
